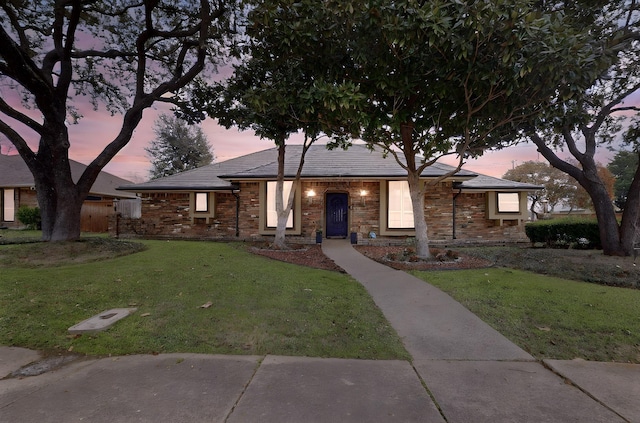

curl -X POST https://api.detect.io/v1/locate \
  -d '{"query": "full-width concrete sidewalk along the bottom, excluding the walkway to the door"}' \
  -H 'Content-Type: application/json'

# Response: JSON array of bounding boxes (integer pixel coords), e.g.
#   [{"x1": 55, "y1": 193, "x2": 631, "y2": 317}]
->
[{"x1": 0, "y1": 347, "x2": 640, "y2": 423}]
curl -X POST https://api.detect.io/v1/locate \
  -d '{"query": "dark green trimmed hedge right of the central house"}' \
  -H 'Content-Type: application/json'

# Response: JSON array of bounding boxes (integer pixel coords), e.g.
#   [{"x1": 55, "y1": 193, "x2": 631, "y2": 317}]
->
[{"x1": 525, "y1": 218, "x2": 602, "y2": 249}]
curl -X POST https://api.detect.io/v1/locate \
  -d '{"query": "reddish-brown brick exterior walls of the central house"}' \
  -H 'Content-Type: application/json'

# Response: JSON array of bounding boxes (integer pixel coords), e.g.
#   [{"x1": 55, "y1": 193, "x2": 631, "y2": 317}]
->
[{"x1": 110, "y1": 180, "x2": 527, "y2": 244}]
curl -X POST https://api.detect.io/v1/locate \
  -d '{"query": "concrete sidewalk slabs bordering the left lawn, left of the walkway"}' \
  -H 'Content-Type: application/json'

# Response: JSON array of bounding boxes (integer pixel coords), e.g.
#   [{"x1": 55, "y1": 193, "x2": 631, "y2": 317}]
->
[{"x1": 0, "y1": 347, "x2": 444, "y2": 423}]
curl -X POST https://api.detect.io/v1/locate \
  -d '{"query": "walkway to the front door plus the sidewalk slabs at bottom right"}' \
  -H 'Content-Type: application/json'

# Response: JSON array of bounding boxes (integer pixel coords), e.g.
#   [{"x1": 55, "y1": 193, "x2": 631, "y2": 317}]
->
[{"x1": 322, "y1": 240, "x2": 640, "y2": 423}]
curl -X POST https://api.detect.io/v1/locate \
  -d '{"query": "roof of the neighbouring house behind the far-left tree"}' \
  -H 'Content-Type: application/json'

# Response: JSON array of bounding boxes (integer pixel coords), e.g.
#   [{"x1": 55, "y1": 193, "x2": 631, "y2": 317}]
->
[{"x1": 0, "y1": 155, "x2": 134, "y2": 198}]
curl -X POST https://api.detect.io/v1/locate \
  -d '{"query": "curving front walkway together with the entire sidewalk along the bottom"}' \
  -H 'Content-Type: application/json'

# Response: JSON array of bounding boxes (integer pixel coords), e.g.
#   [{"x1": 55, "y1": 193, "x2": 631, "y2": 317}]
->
[{"x1": 0, "y1": 240, "x2": 640, "y2": 423}]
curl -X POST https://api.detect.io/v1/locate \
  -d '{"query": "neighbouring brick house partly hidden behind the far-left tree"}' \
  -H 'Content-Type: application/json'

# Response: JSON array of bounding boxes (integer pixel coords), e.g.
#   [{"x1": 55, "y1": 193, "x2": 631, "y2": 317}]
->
[{"x1": 0, "y1": 155, "x2": 136, "y2": 232}]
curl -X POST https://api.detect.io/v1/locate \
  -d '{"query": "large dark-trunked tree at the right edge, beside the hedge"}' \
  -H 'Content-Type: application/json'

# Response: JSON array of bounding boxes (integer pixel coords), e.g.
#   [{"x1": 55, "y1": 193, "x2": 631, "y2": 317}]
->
[{"x1": 524, "y1": 0, "x2": 640, "y2": 255}]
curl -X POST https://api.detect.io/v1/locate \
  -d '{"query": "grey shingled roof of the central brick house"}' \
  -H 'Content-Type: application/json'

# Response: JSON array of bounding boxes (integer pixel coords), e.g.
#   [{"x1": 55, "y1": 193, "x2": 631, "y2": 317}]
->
[{"x1": 118, "y1": 144, "x2": 539, "y2": 192}]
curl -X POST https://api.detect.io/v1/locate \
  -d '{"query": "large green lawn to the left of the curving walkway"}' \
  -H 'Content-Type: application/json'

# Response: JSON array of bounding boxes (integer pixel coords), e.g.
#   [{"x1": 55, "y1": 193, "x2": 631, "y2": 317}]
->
[{"x1": 0, "y1": 241, "x2": 409, "y2": 359}]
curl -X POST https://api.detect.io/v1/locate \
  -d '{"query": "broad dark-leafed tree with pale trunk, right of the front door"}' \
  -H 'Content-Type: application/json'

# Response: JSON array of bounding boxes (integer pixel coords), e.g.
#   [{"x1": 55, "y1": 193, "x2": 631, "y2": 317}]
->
[{"x1": 242, "y1": 0, "x2": 597, "y2": 257}]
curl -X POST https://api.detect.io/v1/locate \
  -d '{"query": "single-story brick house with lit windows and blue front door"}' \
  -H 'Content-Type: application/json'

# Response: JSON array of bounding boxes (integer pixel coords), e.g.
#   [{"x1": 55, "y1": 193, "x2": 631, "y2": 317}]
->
[{"x1": 110, "y1": 145, "x2": 541, "y2": 244}]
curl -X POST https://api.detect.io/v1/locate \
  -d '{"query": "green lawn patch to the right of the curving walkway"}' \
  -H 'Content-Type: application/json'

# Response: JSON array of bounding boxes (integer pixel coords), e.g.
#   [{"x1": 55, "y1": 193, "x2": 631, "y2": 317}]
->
[{"x1": 413, "y1": 268, "x2": 640, "y2": 363}]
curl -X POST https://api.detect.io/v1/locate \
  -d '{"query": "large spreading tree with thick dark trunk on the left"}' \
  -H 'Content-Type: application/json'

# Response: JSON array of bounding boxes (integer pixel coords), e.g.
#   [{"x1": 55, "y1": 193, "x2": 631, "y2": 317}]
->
[{"x1": 0, "y1": 0, "x2": 234, "y2": 241}]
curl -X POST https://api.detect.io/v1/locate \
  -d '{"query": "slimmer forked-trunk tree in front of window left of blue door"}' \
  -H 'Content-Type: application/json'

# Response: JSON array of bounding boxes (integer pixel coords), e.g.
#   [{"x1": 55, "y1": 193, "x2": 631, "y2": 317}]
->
[{"x1": 181, "y1": 5, "x2": 358, "y2": 249}]
